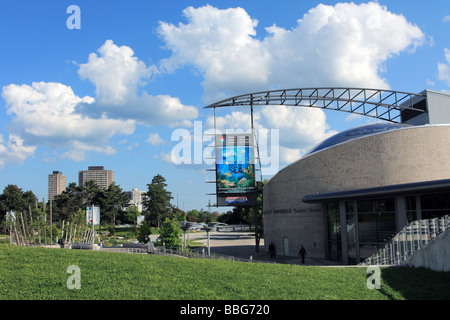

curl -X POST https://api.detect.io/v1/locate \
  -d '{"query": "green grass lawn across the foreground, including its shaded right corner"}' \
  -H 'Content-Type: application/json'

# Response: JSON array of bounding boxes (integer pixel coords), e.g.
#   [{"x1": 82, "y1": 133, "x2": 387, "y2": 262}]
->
[{"x1": 0, "y1": 244, "x2": 450, "y2": 300}]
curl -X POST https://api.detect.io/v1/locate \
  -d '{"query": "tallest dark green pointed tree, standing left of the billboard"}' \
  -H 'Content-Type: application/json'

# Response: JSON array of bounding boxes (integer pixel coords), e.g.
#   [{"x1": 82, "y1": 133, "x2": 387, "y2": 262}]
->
[{"x1": 144, "y1": 174, "x2": 173, "y2": 227}]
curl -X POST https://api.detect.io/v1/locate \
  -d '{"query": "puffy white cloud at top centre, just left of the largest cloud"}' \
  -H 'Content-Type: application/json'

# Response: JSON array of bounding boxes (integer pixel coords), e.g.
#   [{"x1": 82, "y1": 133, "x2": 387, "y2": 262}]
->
[{"x1": 158, "y1": 5, "x2": 268, "y2": 99}]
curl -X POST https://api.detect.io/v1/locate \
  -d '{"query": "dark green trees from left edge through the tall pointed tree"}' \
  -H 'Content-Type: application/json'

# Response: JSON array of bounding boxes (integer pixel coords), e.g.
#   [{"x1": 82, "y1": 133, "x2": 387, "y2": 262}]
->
[{"x1": 0, "y1": 175, "x2": 176, "y2": 227}]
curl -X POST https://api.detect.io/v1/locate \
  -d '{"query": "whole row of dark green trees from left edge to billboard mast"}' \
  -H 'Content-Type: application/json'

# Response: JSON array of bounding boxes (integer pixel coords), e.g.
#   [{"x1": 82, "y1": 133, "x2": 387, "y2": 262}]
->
[{"x1": 0, "y1": 174, "x2": 263, "y2": 246}]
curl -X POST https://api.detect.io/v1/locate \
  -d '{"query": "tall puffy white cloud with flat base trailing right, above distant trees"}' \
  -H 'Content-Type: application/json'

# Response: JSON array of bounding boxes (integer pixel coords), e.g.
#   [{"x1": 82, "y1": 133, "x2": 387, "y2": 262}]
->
[{"x1": 78, "y1": 40, "x2": 198, "y2": 125}]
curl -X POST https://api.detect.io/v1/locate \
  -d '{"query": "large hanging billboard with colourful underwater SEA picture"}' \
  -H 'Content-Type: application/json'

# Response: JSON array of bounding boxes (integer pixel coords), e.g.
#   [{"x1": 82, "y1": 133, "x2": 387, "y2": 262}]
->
[{"x1": 215, "y1": 134, "x2": 256, "y2": 206}]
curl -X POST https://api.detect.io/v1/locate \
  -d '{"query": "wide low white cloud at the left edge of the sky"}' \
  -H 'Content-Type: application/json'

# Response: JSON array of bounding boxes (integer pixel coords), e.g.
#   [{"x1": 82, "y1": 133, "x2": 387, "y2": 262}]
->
[{"x1": 2, "y1": 82, "x2": 135, "y2": 160}]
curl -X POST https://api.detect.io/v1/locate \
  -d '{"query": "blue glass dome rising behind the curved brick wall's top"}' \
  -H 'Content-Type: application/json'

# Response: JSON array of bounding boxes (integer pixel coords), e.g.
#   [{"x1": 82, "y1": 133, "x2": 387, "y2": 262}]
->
[{"x1": 305, "y1": 123, "x2": 409, "y2": 156}]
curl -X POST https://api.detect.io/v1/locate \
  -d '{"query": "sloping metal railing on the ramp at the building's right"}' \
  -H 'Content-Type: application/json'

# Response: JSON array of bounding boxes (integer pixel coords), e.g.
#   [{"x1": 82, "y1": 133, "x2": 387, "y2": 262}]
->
[{"x1": 360, "y1": 215, "x2": 450, "y2": 265}]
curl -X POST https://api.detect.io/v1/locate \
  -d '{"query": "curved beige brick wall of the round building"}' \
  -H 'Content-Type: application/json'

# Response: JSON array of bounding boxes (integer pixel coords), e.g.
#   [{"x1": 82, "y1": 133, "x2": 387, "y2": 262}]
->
[{"x1": 263, "y1": 125, "x2": 450, "y2": 258}]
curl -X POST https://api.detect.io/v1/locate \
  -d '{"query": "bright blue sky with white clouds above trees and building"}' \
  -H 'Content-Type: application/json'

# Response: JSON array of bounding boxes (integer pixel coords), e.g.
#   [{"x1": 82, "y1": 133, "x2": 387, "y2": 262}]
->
[{"x1": 0, "y1": 0, "x2": 450, "y2": 210}]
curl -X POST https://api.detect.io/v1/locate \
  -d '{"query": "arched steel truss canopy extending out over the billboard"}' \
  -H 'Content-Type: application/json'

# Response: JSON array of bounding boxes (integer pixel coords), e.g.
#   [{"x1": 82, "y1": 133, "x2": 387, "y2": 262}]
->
[{"x1": 205, "y1": 88, "x2": 426, "y2": 123}]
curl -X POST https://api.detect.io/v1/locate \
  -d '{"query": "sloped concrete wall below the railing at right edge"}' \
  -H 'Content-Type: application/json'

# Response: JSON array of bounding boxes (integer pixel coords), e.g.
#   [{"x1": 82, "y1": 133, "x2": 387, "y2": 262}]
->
[{"x1": 406, "y1": 229, "x2": 450, "y2": 271}]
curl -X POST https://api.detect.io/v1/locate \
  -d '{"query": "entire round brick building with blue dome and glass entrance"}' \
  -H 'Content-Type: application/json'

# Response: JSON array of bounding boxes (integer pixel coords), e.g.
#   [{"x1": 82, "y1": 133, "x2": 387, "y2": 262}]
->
[{"x1": 263, "y1": 90, "x2": 450, "y2": 264}]
